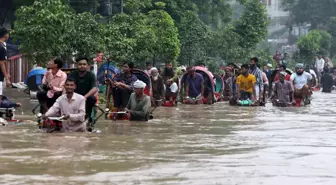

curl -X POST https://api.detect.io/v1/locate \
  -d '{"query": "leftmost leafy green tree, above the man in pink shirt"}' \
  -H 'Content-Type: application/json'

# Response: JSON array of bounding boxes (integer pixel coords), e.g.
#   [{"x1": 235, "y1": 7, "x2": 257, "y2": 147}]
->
[{"x1": 13, "y1": 0, "x2": 101, "y2": 64}]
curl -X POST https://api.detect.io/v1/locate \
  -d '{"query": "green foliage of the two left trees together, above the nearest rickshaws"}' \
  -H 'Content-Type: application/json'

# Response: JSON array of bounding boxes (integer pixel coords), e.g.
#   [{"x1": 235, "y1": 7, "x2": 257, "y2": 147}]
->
[{"x1": 14, "y1": 0, "x2": 180, "y2": 65}]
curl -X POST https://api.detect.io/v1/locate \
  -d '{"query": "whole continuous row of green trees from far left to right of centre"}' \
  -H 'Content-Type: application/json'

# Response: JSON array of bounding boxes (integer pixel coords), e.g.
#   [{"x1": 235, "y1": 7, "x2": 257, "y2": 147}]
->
[{"x1": 14, "y1": 0, "x2": 270, "y2": 69}]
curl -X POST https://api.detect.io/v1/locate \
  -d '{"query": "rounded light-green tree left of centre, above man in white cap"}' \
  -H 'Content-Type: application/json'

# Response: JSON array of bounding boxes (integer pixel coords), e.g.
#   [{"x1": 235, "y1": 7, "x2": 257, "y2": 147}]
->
[{"x1": 105, "y1": 0, "x2": 180, "y2": 65}]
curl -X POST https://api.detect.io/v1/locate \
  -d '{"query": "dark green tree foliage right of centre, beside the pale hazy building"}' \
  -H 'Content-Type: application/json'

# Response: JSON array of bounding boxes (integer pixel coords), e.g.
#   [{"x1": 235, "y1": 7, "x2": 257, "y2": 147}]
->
[{"x1": 213, "y1": 0, "x2": 268, "y2": 62}]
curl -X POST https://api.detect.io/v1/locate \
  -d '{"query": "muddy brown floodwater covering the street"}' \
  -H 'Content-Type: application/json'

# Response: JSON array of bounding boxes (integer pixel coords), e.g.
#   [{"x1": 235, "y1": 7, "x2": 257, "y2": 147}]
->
[{"x1": 0, "y1": 92, "x2": 336, "y2": 185}]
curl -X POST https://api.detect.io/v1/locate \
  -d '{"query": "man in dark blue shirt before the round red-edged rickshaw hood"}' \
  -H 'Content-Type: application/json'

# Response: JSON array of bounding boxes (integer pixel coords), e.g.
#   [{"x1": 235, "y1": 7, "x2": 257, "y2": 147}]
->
[{"x1": 186, "y1": 67, "x2": 204, "y2": 103}]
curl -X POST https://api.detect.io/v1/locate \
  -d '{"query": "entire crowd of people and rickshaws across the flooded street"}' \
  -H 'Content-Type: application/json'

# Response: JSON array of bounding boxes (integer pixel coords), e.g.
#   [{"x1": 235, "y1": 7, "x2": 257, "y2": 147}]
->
[{"x1": 0, "y1": 26, "x2": 335, "y2": 132}]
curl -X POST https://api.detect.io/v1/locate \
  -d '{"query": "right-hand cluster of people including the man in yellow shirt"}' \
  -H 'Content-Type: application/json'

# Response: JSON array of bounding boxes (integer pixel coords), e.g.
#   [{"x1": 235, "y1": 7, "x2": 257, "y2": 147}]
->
[{"x1": 219, "y1": 55, "x2": 336, "y2": 106}]
